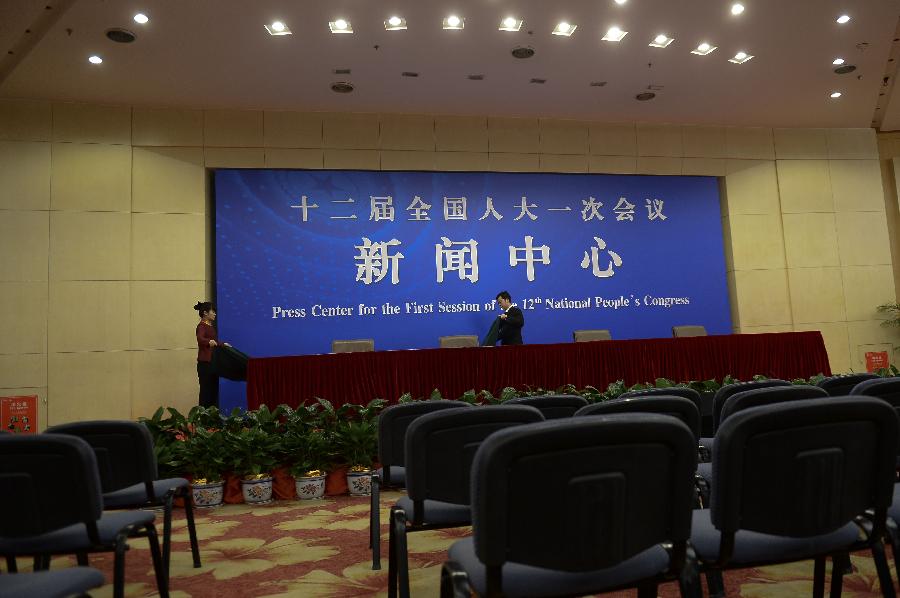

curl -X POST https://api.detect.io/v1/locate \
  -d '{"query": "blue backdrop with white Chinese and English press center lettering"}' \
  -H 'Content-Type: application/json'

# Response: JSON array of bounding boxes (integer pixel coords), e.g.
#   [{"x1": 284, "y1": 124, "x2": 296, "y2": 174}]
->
[{"x1": 215, "y1": 170, "x2": 731, "y2": 404}]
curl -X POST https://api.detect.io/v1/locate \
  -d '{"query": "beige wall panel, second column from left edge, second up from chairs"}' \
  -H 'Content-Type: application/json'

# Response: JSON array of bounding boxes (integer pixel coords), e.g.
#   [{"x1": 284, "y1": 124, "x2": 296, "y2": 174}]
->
[{"x1": 48, "y1": 280, "x2": 132, "y2": 353}]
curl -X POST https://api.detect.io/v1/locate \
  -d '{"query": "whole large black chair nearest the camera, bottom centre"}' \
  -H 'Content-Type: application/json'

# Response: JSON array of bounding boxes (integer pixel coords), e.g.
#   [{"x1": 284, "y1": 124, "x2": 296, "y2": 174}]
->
[{"x1": 441, "y1": 414, "x2": 697, "y2": 598}]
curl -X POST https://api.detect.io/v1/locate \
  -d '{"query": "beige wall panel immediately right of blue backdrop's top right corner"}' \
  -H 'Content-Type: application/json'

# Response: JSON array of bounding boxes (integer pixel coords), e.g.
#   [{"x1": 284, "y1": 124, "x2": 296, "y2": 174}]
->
[{"x1": 725, "y1": 160, "x2": 780, "y2": 214}]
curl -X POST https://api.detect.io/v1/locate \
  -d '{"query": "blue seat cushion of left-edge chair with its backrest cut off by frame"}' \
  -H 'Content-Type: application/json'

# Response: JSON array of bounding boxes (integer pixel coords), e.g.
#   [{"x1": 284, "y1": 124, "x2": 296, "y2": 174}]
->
[{"x1": 0, "y1": 511, "x2": 156, "y2": 555}]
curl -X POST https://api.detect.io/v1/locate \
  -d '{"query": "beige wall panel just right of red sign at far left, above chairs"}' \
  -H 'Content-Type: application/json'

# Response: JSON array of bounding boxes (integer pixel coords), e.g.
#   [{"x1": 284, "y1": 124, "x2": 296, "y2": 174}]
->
[{"x1": 47, "y1": 351, "x2": 132, "y2": 426}]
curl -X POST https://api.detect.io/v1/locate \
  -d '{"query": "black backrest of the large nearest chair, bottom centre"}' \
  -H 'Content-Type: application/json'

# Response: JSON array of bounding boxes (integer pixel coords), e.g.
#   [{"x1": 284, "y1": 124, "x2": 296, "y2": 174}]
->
[{"x1": 472, "y1": 413, "x2": 697, "y2": 595}]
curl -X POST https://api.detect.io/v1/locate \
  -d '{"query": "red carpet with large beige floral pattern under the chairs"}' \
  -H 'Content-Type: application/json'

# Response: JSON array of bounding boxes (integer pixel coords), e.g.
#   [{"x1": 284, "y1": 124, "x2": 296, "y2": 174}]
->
[{"x1": 22, "y1": 492, "x2": 893, "y2": 598}]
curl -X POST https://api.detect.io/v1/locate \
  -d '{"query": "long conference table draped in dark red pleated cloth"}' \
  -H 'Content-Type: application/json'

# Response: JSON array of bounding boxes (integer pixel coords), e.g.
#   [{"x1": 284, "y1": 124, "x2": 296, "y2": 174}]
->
[{"x1": 247, "y1": 331, "x2": 831, "y2": 409}]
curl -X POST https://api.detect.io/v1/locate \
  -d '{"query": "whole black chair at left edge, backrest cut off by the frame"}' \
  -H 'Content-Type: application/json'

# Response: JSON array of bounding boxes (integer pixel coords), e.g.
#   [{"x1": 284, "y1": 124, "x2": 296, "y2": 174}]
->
[{"x1": 0, "y1": 434, "x2": 169, "y2": 598}]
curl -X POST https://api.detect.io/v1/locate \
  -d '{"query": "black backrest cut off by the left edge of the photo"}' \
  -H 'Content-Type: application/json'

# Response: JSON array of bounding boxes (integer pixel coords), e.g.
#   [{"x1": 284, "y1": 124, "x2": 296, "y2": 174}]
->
[{"x1": 0, "y1": 434, "x2": 103, "y2": 542}]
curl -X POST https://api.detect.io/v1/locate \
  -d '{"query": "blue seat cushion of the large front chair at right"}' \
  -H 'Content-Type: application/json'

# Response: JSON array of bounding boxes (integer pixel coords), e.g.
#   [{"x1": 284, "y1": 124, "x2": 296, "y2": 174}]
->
[{"x1": 691, "y1": 509, "x2": 861, "y2": 566}]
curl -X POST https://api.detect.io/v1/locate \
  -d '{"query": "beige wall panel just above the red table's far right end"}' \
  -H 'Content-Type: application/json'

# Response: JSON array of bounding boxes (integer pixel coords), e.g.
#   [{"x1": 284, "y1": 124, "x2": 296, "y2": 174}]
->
[{"x1": 788, "y1": 268, "x2": 846, "y2": 324}]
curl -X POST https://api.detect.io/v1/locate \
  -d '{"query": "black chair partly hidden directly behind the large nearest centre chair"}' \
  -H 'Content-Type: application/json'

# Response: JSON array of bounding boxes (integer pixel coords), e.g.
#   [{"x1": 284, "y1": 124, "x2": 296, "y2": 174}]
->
[{"x1": 388, "y1": 405, "x2": 544, "y2": 598}]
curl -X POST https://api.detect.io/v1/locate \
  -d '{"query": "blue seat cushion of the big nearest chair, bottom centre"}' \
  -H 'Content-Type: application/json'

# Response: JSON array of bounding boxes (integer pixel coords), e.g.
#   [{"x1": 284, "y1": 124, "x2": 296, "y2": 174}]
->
[{"x1": 449, "y1": 538, "x2": 669, "y2": 596}]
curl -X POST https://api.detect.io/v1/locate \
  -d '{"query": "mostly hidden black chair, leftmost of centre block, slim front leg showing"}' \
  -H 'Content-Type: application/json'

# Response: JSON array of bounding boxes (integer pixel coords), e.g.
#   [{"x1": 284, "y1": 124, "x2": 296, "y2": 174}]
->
[{"x1": 369, "y1": 401, "x2": 470, "y2": 570}]
